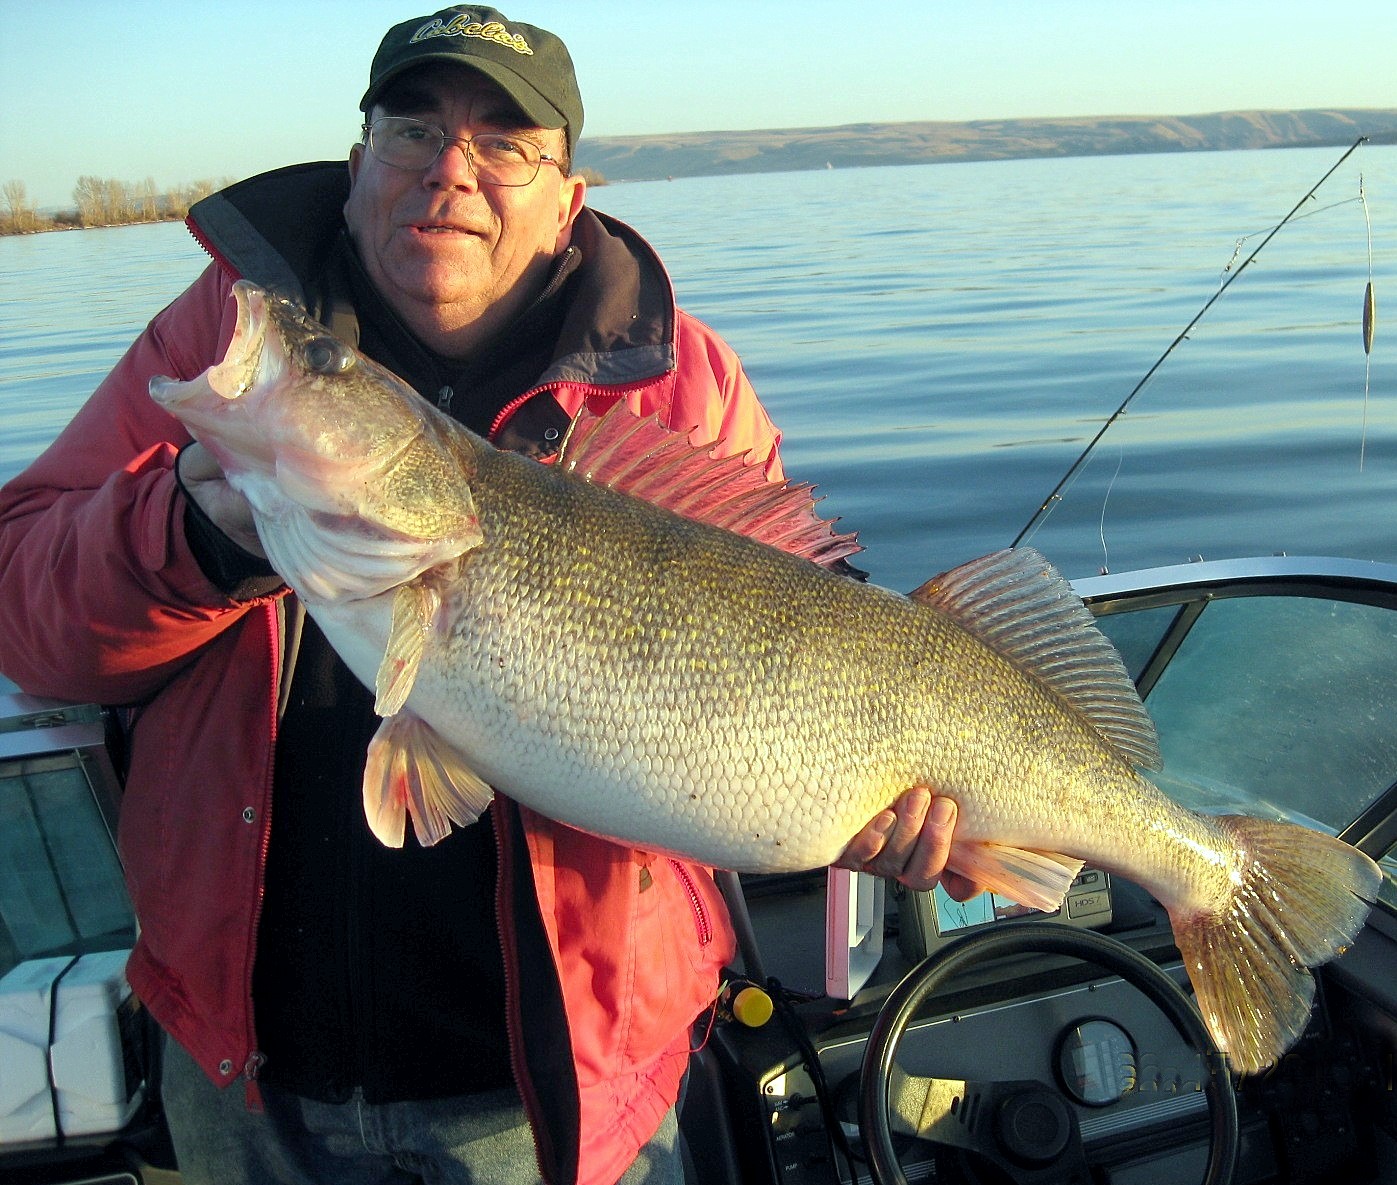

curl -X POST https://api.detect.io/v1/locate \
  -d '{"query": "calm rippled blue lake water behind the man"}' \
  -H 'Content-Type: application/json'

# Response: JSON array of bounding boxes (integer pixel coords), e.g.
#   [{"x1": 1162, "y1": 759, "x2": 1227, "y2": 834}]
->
[{"x1": 0, "y1": 147, "x2": 1397, "y2": 588}]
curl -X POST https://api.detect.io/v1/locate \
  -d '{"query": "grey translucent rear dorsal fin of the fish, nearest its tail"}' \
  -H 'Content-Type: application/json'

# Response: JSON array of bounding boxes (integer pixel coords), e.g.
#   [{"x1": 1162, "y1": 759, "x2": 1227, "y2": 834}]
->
[{"x1": 911, "y1": 548, "x2": 1161, "y2": 770}]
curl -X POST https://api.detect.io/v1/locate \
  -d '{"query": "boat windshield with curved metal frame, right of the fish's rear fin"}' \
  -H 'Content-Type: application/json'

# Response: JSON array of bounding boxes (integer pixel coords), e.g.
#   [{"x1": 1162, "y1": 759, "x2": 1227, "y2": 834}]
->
[{"x1": 1077, "y1": 559, "x2": 1397, "y2": 904}]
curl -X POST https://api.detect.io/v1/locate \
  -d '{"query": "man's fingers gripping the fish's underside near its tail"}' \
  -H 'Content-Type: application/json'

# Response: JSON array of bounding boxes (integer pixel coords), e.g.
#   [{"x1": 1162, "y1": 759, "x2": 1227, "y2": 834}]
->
[{"x1": 834, "y1": 785, "x2": 979, "y2": 901}]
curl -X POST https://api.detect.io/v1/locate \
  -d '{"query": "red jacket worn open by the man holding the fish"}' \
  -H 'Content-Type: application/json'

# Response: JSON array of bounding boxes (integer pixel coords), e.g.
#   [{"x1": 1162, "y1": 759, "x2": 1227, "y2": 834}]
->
[{"x1": 0, "y1": 173, "x2": 780, "y2": 1185}]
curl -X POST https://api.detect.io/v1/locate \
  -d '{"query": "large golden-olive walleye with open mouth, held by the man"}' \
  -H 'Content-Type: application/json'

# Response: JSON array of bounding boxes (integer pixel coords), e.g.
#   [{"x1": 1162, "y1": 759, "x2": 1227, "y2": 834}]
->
[{"x1": 151, "y1": 282, "x2": 1380, "y2": 1072}]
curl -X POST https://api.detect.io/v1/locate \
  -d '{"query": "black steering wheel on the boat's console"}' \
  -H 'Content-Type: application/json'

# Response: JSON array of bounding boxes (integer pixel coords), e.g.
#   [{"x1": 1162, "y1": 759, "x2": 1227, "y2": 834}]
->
[{"x1": 859, "y1": 922, "x2": 1238, "y2": 1185}]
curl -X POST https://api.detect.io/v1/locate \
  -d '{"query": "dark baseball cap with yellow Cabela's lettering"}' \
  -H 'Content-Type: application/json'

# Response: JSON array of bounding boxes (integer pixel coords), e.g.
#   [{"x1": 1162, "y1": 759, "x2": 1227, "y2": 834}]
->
[{"x1": 359, "y1": 4, "x2": 583, "y2": 151}]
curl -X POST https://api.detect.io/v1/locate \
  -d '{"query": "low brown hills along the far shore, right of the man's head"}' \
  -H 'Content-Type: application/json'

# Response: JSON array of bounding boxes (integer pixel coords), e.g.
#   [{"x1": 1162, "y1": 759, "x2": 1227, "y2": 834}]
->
[{"x1": 577, "y1": 108, "x2": 1397, "y2": 182}]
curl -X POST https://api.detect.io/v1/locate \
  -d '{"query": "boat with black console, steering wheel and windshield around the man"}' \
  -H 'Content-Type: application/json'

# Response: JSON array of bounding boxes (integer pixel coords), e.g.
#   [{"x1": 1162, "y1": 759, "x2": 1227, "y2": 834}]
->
[{"x1": 0, "y1": 556, "x2": 1397, "y2": 1185}]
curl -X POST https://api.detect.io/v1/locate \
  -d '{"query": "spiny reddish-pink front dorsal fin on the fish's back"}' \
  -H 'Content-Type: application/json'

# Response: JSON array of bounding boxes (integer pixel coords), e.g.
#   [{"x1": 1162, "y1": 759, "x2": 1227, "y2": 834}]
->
[{"x1": 557, "y1": 401, "x2": 862, "y2": 566}]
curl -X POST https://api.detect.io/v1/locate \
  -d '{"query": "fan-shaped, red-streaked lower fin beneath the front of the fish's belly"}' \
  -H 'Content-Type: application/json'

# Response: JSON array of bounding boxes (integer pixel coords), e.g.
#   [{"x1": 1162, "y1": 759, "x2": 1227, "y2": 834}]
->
[{"x1": 363, "y1": 713, "x2": 495, "y2": 848}]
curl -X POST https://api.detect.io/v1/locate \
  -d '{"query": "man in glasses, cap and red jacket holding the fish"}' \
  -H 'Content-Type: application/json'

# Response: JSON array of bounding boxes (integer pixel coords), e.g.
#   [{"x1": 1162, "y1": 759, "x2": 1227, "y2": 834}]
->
[{"x1": 0, "y1": 8, "x2": 953, "y2": 1185}]
